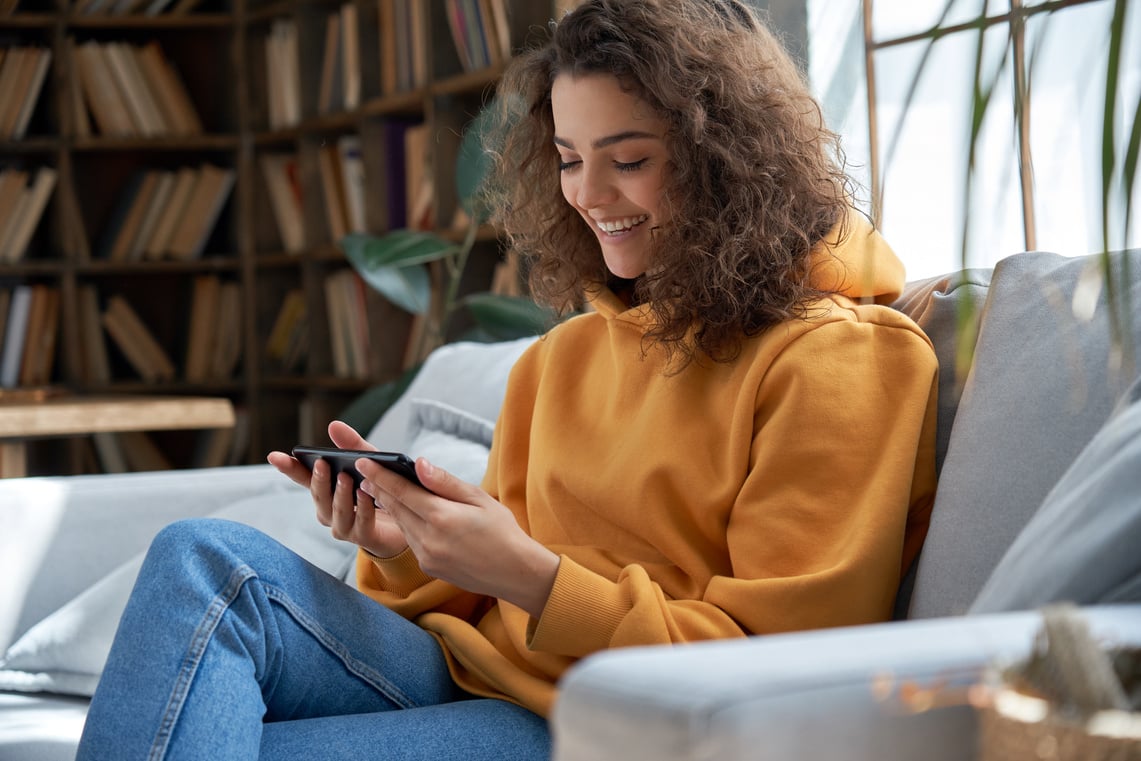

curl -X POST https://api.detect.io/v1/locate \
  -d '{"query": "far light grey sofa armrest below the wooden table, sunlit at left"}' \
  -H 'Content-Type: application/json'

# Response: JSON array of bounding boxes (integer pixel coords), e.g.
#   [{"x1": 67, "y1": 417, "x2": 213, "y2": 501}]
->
[{"x1": 0, "y1": 464, "x2": 298, "y2": 653}]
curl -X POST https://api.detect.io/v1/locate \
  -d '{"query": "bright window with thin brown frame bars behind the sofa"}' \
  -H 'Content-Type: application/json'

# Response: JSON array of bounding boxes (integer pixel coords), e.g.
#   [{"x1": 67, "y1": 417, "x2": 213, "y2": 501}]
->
[{"x1": 808, "y1": 0, "x2": 1141, "y2": 278}]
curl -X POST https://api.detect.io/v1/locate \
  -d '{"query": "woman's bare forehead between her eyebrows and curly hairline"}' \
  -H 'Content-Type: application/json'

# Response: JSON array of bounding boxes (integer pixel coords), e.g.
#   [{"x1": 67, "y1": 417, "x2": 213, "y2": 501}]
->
[{"x1": 551, "y1": 74, "x2": 665, "y2": 140}]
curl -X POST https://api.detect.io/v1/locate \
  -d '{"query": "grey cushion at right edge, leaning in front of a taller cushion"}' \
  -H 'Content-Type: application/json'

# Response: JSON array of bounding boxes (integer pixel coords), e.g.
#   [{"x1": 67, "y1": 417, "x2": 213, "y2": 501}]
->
[{"x1": 971, "y1": 378, "x2": 1141, "y2": 613}]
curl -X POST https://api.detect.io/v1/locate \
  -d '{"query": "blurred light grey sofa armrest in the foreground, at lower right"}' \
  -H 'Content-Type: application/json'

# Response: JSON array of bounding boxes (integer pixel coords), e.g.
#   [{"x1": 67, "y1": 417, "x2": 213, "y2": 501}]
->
[{"x1": 552, "y1": 605, "x2": 1141, "y2": 761}]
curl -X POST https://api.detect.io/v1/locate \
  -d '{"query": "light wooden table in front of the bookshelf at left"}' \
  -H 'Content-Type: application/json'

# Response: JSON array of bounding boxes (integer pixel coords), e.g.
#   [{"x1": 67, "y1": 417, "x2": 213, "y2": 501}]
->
[{"x1": 0, "y1": 396, "x2": 234, "y2": 478}]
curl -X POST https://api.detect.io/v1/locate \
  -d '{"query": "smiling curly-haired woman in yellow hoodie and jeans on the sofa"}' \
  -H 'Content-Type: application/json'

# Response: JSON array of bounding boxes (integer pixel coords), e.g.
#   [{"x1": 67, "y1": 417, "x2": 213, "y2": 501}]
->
[{"x1": 80, "y1": 0, "x2": 937, "y2": 759}]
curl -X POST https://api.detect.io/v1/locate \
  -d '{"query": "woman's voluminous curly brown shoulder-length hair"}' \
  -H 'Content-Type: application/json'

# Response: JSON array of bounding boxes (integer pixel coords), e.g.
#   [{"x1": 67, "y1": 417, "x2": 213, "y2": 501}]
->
[{"x1": 491, "y1": 0, "x2": 851, "y2": 364}]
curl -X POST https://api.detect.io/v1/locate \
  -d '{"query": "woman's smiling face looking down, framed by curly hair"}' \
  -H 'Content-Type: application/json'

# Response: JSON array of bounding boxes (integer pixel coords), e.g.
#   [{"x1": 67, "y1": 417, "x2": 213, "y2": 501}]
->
[{"x1": 551, "y1": 74, "x2": 669, "y2": 277}]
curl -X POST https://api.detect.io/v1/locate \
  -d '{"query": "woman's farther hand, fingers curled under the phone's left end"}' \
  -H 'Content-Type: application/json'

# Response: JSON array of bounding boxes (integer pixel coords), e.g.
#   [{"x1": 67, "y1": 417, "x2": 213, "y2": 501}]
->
[{"x1": 266, "y1": 420, "x2": 408, "y2": 558}]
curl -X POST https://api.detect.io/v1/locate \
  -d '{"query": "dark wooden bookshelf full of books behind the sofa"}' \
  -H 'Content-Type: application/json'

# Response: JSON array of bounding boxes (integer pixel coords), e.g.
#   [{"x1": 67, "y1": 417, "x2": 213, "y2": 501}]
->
[{"x1": 0, "y1": 0, "x2": 573, "y2": 473}]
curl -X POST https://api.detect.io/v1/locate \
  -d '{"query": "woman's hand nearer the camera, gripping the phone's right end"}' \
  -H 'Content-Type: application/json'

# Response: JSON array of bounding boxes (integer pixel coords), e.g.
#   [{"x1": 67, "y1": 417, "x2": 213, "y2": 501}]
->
[{"x1": 356, "y1": 458, "x2": 559, "y2": 618}]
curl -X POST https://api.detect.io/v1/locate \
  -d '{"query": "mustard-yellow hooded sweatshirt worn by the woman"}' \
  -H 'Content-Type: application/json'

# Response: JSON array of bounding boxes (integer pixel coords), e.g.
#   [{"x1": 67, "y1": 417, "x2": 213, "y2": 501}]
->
[{"x1": 358, "y1": 218, "x2": 938, "y2": 715}]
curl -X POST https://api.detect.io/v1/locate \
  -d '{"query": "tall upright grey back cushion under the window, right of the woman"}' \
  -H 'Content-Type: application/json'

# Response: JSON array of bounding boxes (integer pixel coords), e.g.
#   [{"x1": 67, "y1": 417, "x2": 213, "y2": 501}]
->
[{"x1": 909, "y1": 251, "x2": 1141, "y2": 617}]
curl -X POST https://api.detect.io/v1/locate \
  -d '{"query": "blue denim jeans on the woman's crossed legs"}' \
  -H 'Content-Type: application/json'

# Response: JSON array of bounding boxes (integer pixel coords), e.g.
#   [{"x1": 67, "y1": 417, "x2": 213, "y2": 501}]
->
[{"x1": 78, "y1": 519, "x2": 550, "y2": 761}]
